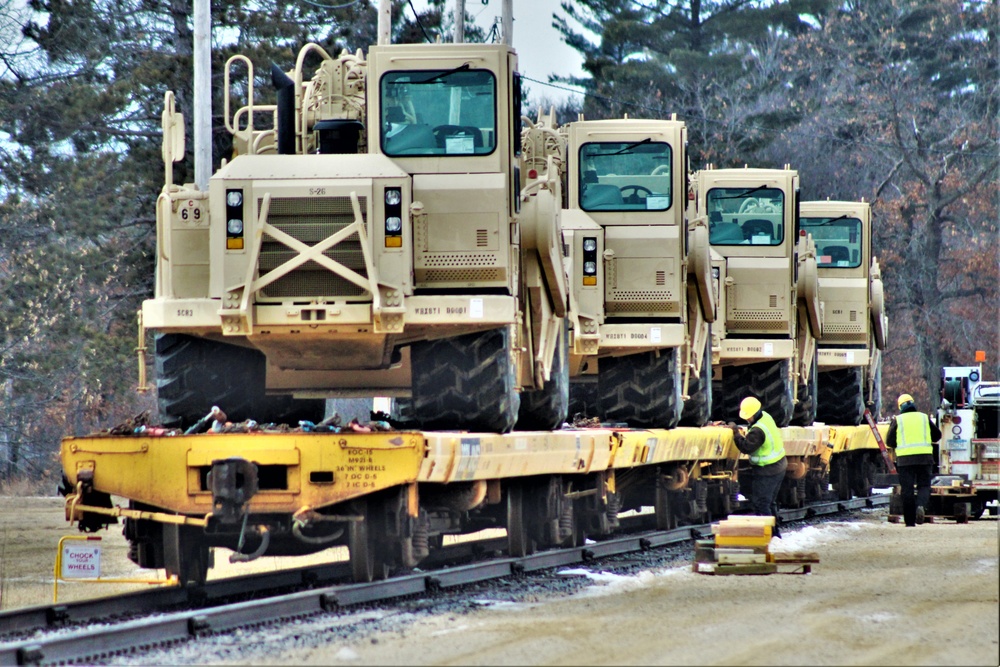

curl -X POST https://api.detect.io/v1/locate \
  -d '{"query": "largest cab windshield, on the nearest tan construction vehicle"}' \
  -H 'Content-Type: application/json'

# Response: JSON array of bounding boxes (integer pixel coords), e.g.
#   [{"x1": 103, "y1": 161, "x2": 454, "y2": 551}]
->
[{"x1": 379, "y1": 65, "x2": 497, "y2": 155}]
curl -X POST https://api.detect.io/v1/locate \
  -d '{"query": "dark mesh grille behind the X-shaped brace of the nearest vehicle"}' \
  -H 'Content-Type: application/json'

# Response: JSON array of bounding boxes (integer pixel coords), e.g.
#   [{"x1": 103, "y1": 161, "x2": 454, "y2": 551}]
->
[{"x1": 257, "y1": 197, "x2": 368, "y2": 299}]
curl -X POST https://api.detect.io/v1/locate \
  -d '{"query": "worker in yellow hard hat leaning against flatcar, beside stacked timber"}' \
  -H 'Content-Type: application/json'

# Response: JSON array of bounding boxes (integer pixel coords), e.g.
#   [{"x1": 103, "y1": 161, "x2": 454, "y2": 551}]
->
[{"x1": 731, "y1": 396, "x2": 788, "y2": 537}]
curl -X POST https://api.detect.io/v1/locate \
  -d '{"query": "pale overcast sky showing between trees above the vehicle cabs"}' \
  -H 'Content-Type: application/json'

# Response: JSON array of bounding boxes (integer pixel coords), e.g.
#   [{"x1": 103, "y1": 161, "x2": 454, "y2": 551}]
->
[{"x1": 413, "y1": 0, "x2": 583, "y2": 101}]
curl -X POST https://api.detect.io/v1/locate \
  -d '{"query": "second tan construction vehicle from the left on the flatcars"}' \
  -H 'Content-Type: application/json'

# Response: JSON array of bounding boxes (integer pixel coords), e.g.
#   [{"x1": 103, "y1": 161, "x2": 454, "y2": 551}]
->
[{"x1": 525, "y1": 117, "x2": 715, "y2": 428}]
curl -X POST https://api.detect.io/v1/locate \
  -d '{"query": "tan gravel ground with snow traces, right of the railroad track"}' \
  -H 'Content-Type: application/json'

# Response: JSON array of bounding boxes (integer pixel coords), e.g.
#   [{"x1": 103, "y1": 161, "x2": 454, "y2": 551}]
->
[{"x1": 105, "y1": 509, "x2": 1000, "y2": 665}]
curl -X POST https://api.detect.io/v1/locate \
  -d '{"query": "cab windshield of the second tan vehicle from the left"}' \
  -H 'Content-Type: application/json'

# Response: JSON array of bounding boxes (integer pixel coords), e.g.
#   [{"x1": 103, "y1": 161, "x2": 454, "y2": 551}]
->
[{"x1": 580, "y1": 139, "x2": 672, "y2": 211}]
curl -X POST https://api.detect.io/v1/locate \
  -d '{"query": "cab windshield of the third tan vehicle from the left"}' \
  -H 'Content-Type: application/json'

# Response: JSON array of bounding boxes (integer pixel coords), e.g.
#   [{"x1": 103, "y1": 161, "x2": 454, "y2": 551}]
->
[{"x1": 707, "y1": 185, "x2": 785, "y2": 246}]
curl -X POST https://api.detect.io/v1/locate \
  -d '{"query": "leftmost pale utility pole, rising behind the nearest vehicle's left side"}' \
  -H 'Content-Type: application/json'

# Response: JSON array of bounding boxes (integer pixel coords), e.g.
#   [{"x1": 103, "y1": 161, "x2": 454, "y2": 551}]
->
[{"x1": 191, "y1": 0, "x2": 212, "y2": 192}]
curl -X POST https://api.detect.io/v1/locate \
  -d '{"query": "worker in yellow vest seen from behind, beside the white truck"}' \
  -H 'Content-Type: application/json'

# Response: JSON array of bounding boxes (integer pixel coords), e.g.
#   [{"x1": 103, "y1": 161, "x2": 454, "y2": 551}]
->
[{"x1": 885, "y1": 394, "x2": 941, "y2": 526}]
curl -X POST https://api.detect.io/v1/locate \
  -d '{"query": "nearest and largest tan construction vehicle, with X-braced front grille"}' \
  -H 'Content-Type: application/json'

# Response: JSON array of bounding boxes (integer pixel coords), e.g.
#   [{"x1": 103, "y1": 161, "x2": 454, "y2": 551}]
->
[{"x1": 140, "y1": 44, "x2": 568, "y2": 432}]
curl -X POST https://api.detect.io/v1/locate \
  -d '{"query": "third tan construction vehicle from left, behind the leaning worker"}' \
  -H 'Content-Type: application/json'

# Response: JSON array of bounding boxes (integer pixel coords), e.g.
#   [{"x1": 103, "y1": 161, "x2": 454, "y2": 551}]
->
[{"x1": 692, "y1": 166, "x2": 823, "y2": 426}]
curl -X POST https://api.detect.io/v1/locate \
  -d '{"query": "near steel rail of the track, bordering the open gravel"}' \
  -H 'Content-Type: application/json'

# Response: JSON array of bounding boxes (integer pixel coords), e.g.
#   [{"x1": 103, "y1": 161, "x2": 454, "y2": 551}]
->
[{"x1": 0, "y1": 495, "x2": 889, "y2": 665}]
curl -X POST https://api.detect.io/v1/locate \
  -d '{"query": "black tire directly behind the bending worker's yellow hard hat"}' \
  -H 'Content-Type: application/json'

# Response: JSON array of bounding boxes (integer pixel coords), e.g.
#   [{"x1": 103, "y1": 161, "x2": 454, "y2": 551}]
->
[{"x1": 722, "y1": 359, "x2": 793, "y2": 428}]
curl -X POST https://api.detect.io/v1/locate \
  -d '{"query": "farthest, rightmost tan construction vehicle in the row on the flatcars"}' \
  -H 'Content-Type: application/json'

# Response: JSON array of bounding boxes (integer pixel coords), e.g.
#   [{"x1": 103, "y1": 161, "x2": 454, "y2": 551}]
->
[{"x1": 799, "y1": 201, "x2": 888, "y2": 425}]
